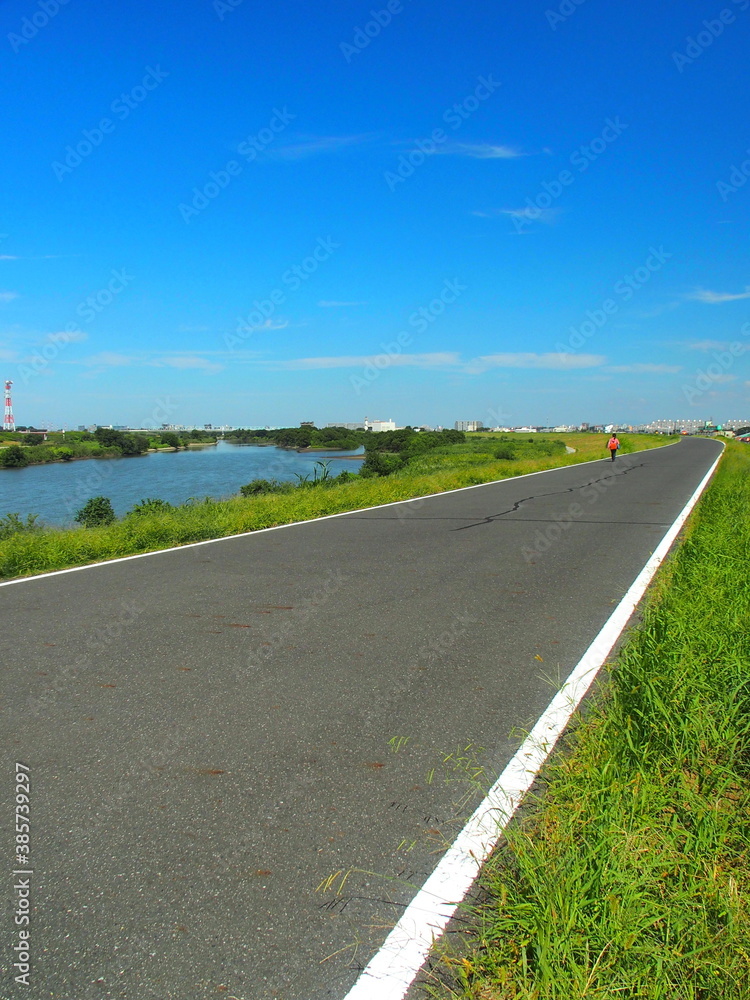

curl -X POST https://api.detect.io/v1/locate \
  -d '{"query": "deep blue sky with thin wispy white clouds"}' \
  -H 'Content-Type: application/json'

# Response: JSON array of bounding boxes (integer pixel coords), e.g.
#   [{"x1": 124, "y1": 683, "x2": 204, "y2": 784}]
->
[{"x1": 0, "y1": 0, "x2": 750, "y2": 426}]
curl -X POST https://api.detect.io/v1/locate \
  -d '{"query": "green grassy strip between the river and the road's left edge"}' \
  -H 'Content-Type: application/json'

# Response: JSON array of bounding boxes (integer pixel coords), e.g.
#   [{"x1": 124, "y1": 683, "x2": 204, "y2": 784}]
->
[{"x1": 0, "y1": 434, "x2": 671, "y2": 579}]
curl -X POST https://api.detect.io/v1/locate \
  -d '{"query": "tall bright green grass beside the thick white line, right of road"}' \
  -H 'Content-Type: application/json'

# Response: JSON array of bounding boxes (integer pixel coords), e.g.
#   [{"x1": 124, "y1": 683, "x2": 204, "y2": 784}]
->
[{"x1": 435, "y1": 444, "x2": 750, "y2": 1000}]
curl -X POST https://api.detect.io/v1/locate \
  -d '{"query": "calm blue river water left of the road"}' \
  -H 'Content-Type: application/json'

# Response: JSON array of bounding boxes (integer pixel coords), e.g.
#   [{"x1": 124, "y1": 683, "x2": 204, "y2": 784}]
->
[{"x1": 0, "y1": 441, "x2": 364, "y2": 525}]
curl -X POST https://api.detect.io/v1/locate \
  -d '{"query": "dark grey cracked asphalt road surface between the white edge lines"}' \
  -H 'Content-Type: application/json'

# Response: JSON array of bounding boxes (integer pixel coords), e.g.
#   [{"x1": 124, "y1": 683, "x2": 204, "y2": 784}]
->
[{"x1": 0, "y1": 440, "x2": 720, "y2": 1000}]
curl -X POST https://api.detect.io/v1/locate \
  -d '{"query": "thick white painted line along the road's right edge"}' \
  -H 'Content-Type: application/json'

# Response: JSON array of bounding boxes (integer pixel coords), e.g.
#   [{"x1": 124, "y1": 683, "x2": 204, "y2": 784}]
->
[{"x1": 344, "y1": 448, "x2": 724, "y2": 1000}]
